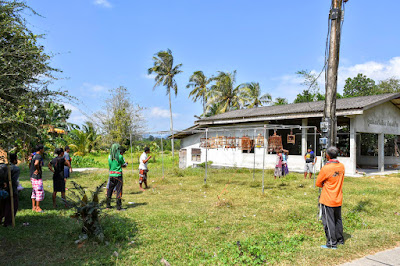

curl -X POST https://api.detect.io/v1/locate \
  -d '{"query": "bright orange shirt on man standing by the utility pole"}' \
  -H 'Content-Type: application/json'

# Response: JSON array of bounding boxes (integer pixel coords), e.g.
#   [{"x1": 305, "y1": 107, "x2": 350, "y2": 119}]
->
[{"x1": 316, "y1": 160, "x2": 344, "y2": 207}]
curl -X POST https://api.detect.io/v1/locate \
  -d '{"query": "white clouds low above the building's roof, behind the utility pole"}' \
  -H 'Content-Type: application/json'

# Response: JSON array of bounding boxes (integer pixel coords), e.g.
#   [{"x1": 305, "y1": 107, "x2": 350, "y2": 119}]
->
[{"x1": 271, "y1": 57, "x2": 400, "y2": 102}]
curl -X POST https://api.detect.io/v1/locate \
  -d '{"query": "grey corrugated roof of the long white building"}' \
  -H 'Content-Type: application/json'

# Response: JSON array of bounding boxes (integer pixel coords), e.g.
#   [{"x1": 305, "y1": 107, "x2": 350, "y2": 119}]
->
[{"x1": 196, "y1": 93, "x2": 400, "y2": 123}]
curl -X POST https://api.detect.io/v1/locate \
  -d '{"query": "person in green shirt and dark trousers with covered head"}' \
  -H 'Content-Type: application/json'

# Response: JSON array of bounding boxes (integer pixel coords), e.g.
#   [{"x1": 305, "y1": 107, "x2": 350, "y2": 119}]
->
[{"x1": 107, "y1": 143, "x2": 127, "y2": 211}]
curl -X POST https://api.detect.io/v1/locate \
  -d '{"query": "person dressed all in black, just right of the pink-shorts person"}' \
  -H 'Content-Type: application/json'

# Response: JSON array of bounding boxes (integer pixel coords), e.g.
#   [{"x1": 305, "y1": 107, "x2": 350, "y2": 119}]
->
[{"x1": 48, "y1": 148, "x2": 71, "y2": 208}]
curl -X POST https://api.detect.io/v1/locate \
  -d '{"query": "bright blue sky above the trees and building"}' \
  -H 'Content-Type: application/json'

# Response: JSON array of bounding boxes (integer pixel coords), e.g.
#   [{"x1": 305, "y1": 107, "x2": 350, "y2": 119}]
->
[{"x1": 27, "y1": 0, "x2": 400, "y2": 131}]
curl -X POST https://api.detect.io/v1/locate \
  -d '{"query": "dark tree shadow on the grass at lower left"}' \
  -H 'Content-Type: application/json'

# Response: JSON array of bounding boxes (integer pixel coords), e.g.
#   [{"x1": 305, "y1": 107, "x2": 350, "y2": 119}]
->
[{"x1": 0, "y1": 206, "x2": 139, "y2": 265}]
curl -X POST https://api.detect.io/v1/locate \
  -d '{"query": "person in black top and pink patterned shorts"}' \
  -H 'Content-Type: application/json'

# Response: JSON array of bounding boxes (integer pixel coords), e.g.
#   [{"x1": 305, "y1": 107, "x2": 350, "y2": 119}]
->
[{"x1": 29, "y1": 144, "x2": 44, "y2": 212}]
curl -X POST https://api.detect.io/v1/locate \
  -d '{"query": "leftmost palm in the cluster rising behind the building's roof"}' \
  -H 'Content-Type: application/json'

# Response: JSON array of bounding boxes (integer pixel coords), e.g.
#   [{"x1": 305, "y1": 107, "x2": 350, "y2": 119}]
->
[{"x1": 186, "y1": 71, "x2": 212, "y2": 114}]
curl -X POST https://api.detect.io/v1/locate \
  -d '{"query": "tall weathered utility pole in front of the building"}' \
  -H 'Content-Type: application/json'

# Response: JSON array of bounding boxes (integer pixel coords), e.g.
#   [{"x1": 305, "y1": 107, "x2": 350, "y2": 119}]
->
[{"x1": 321, "y1": 0, "x2": 348, "y2": 147}]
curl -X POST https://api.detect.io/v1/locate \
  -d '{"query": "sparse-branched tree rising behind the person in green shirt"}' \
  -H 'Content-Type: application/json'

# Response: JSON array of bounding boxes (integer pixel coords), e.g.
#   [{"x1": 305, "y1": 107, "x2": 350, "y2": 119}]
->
[{"x1": 95, "y1": 86, "x2": 145, "y2": 148}]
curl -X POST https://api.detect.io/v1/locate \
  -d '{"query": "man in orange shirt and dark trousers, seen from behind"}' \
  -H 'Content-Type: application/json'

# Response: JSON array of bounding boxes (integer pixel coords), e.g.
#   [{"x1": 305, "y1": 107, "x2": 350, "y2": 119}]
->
[{"x1": 316, "y1": 147, "x2": 345, "y2": 249}]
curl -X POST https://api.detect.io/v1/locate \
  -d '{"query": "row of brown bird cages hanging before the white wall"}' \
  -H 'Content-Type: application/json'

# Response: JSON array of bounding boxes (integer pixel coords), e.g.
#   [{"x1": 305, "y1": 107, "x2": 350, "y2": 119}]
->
[{"x1": 200, "y1": 134, "x2": 264, "y2": 150}]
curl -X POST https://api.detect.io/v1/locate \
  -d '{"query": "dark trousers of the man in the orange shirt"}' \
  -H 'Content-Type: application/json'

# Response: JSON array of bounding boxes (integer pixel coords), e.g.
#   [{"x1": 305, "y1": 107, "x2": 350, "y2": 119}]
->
[{"x1": 321, "y1": 204, "x2": 344, "y2": 247}]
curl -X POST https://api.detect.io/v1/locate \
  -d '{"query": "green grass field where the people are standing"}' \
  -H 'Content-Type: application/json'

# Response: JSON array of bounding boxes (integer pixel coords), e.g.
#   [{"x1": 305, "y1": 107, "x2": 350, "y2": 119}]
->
[{"x1": 0, "y1": 157, "x2": 400, "y2": 265}]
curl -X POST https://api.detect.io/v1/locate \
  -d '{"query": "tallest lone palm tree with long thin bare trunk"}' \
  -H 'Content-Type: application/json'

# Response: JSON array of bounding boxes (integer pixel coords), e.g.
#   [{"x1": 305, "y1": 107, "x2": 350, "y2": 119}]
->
[{"x1": 148, "y1": 49, "x2": 182, "y2": 158}]
